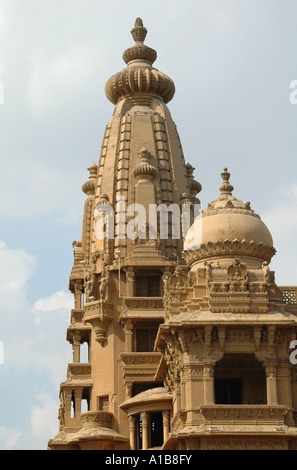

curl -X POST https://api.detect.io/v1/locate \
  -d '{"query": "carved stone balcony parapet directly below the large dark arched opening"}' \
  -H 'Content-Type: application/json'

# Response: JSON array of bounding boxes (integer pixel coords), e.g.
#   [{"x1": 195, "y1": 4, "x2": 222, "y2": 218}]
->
[{"x1": 200, "y1": 405, "x2": 288, "y2": 425}]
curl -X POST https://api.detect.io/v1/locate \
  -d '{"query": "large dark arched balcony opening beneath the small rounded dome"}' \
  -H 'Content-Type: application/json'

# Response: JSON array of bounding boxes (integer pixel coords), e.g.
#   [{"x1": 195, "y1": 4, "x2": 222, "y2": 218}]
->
[{"x1": 214, "y1": 354, "x2": 267, "y2": 405}]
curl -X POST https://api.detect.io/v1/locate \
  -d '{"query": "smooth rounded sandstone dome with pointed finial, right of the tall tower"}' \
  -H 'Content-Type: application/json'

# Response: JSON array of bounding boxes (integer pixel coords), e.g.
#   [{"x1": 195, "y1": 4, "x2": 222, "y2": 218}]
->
[{"x1": 184, "y1": 168, "x2": 275, "y2": 263}]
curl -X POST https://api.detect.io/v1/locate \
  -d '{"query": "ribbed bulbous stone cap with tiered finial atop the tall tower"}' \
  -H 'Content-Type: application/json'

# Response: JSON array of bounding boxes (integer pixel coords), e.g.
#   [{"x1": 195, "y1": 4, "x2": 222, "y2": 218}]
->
[{"x1": 105, "y1": 18, "x2": 175, "y2": 105}]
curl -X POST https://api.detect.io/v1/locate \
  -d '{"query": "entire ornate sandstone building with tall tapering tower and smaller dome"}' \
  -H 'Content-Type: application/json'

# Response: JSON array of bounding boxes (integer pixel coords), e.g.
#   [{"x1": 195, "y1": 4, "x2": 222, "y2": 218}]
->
[{"x1": 48, "y1": 18, "x2": 297, "y2": 450}]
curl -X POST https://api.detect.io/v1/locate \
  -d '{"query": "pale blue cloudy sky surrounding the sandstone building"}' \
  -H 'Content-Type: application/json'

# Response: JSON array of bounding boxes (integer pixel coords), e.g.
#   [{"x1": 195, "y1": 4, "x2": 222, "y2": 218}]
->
[{"x1": 0, "y1": 0, "x2": 297, "y2": 450}]
